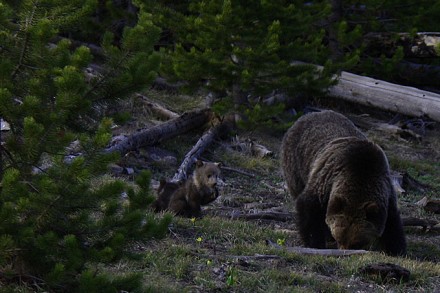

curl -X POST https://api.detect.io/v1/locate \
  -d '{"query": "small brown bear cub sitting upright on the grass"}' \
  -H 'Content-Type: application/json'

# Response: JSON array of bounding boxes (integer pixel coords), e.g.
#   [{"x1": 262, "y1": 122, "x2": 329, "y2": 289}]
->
[{"x1": 153, "y1": 160, "x2": 220, "y2": 218}]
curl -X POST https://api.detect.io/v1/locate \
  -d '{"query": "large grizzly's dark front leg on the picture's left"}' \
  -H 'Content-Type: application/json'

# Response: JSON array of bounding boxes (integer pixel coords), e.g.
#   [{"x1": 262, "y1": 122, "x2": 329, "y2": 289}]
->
[{"x1": 296, "y1": 192, "x2": 328, "y2": 248}]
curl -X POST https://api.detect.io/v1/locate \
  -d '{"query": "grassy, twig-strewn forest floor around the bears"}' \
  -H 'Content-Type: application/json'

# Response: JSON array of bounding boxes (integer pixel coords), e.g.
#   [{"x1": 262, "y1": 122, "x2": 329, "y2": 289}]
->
[{"x1": 112, "y1": 92, "x2": 440, "y2": 292}]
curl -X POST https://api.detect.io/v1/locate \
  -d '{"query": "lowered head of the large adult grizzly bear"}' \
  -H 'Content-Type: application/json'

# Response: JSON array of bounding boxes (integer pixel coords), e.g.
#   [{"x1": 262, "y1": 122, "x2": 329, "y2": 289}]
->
[{"x1": 325, "y1": 198, "x2": 387, "y2": 250}]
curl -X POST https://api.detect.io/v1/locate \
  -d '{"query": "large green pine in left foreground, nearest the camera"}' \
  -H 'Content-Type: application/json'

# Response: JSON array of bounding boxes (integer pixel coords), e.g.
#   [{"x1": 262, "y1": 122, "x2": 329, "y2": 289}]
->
[{"x1": 0, "y1": 0, "x2": 170, "y2": 292}]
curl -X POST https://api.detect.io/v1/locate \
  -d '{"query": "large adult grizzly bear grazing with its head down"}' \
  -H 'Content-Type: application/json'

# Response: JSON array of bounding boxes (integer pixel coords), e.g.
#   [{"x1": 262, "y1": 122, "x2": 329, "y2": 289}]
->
[{"x1": 281, "y1": 111, "x2": 406, "y2": 255}]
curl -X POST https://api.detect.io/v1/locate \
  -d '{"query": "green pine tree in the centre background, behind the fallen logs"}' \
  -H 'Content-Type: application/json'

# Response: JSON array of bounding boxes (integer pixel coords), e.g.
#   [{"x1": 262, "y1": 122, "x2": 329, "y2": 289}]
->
[{"x1": 143, "y1": 0, "x2": 331, "y2": 128}]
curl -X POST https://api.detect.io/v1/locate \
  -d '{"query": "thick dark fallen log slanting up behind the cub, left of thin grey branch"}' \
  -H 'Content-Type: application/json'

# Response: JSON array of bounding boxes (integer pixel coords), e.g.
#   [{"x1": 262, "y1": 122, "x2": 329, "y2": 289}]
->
[{"x1": 105, "y1": 109, "x2": 213, "y2": 155}]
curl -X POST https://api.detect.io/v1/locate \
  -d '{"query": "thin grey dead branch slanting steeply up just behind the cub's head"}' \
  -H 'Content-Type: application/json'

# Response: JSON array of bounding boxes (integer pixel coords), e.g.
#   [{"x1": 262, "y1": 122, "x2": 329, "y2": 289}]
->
[{"x1": 172, "y1": 124, "x2": 224, "y2": 182}]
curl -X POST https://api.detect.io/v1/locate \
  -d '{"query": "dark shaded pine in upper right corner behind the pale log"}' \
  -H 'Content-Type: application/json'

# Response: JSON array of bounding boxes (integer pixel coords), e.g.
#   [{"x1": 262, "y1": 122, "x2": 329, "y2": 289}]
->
[{"x1": 328, "y1": 0, "x2": 440, "y2": 82}]
